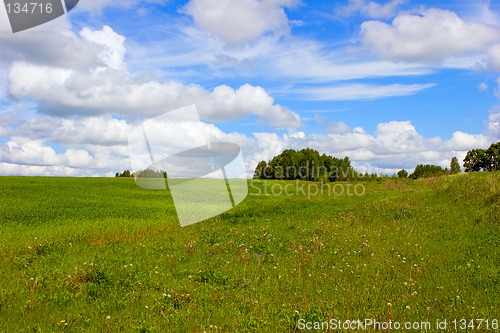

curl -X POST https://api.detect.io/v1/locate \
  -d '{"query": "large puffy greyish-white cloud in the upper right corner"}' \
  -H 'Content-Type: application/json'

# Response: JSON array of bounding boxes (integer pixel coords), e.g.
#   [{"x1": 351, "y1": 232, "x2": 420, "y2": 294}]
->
[{"x1": 361, "y1": 8, "x2": 500, "y2": 63}]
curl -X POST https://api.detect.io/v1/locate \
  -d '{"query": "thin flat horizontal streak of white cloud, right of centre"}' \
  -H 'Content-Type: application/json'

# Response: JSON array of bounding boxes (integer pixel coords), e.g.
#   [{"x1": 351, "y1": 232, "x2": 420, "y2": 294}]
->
[{"x1": 296, "y1": 83, "x2": 435, "y2": 101}]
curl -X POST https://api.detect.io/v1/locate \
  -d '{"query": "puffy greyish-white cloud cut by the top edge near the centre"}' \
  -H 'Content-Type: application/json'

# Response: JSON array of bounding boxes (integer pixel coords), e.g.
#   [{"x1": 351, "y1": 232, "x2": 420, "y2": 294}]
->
[{"x1": 183, "y1": 0, "x2": 299, "y2": 44}]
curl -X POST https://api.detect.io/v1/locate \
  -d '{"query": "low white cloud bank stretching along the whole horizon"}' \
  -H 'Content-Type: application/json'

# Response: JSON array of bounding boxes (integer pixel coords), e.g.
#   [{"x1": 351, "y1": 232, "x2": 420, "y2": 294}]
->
[{"x1": 0, "y1": 114, "x2": 500, "y2": 176}]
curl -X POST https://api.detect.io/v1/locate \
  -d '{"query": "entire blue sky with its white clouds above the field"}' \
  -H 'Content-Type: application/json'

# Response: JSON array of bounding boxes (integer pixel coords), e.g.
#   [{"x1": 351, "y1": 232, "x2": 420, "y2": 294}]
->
[{"x1": 0, "y1": 0, "x2": 500, "y2": 176}]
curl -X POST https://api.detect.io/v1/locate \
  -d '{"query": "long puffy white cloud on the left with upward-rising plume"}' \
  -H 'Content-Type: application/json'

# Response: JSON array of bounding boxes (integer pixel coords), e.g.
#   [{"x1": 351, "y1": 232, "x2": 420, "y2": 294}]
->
[{"x1": 9, "y1": 26, "x2": 302, "y2": 128}]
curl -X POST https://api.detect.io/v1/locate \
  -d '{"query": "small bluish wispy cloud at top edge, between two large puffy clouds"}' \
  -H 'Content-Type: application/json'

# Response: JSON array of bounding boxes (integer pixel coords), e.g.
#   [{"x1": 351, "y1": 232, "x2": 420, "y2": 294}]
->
[{"x1": 337, "y1": 0, "x2": 407, "y2": 19}]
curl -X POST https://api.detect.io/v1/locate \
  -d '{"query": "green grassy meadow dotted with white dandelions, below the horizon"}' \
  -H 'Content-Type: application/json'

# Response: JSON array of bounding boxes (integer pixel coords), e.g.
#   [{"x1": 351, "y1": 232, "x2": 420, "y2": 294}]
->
[{"x1": 0, "y1": 172, "x2": 500, "y2": 332}]
